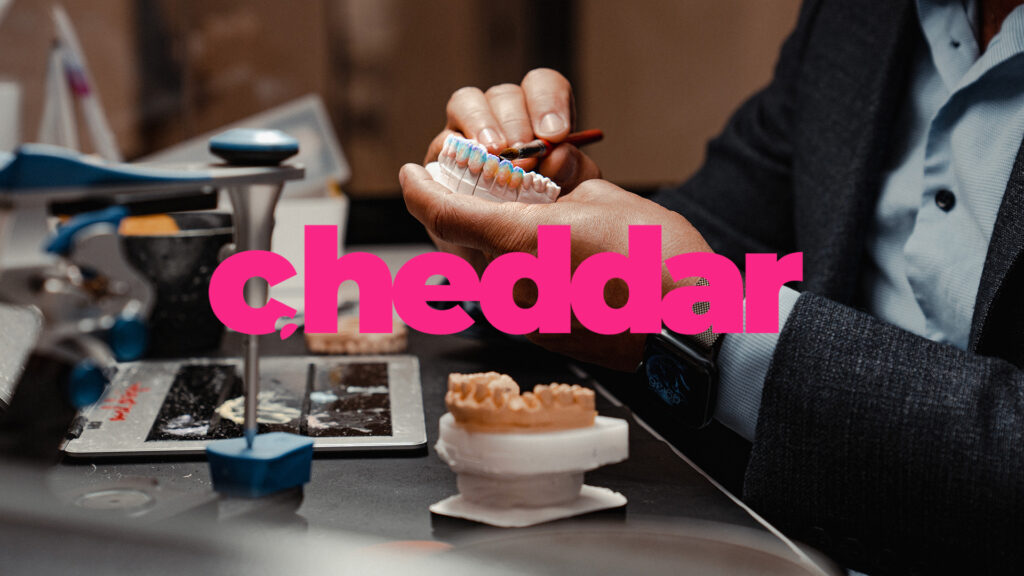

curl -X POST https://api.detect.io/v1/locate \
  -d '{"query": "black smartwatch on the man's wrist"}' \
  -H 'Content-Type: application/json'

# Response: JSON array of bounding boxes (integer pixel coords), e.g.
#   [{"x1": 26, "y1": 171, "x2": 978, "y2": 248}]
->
[{"x1": 641, "y1": 282, "x2": 723, "y2": 428}]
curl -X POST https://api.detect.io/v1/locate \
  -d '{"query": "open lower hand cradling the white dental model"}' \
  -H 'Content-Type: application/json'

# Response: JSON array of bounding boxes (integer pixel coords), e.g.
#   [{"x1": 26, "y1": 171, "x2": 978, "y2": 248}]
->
[{"x1": 399, "y1": 159, "x2": 712, "y2": 370}]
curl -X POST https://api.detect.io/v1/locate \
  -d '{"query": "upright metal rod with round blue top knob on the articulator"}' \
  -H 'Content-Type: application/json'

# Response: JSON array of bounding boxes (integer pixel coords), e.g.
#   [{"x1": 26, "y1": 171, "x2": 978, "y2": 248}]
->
[{"x1": 210, "y1": 128, "x2": 299, "y2": 450}]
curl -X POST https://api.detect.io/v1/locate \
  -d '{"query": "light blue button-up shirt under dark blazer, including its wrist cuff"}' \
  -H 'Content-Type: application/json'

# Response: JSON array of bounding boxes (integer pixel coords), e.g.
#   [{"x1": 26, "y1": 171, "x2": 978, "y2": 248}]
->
[{"x1": 715, "y1": 0, "x2": 1024, "y2": 440}]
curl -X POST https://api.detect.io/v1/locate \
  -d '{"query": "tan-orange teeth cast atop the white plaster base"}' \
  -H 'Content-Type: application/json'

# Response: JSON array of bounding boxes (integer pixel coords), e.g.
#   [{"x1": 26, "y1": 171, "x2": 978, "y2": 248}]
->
[{"x1": 444, "y1": 372, "x2": 597, "y2": 433}]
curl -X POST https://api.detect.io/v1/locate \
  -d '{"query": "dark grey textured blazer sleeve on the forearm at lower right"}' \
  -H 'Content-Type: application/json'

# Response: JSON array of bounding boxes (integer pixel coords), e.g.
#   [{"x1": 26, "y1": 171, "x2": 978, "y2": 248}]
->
[{"x1": 744, "y1": 294, "x2": 1024, "y2": 572}]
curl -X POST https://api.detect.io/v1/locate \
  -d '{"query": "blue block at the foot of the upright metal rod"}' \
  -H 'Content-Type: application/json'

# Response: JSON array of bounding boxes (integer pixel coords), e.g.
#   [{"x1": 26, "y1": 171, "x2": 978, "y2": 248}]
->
[{"x1": 206, "y1": 433, "x2": 313, "y2": 498}]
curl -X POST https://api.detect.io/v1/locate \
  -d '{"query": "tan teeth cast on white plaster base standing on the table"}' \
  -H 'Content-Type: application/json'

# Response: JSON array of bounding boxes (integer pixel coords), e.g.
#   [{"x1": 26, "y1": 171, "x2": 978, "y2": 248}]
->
[{"x1": 430, "y1": 372, "x2": 629, "y2": 527}]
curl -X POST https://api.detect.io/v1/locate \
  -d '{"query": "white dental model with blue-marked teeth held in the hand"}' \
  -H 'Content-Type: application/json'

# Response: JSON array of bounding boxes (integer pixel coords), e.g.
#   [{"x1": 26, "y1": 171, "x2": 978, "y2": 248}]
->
[{"x1": 427, "y1": 134, "x2": 561, "y2": 204}]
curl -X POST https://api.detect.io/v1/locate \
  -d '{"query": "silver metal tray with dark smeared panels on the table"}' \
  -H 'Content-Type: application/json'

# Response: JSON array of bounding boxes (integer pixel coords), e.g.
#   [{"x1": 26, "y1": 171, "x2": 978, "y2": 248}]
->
[{"x1": 63, "y1": 356, "x2": 426, "y2": 457}]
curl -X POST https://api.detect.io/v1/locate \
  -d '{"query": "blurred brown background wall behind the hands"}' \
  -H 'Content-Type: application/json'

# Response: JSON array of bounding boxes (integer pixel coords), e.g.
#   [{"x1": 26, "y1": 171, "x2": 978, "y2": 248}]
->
[{"x1": 0, "y1": 0, "x2": 800, "y2": 243}]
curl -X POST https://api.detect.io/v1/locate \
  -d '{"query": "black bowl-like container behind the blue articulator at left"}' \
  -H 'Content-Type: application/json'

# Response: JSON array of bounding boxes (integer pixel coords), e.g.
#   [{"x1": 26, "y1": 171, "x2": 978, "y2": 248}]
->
[{"x1": 121, "y1": 212, "x2": 232, "y2": 358}]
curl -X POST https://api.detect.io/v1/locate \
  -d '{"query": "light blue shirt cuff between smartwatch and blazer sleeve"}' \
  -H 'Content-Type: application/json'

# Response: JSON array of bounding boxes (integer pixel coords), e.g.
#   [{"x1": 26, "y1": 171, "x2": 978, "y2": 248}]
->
[{"x1": 715, "y1": 286, "x2": 800, "y2": 442}]
